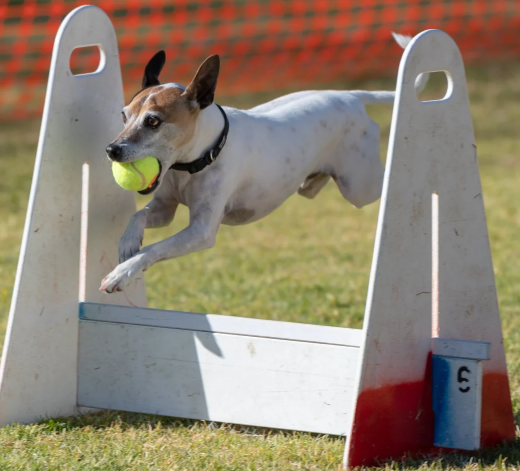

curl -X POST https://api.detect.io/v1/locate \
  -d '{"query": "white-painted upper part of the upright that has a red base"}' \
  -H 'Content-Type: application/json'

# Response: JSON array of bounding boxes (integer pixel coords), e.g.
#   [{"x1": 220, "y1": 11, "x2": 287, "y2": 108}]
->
[{"x1": 344, "y1": 30, "x2": 507, "y2": 466}]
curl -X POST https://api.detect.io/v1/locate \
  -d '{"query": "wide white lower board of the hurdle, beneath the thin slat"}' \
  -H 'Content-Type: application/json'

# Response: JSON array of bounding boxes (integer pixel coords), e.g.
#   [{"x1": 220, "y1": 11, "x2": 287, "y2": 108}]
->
[{"x1": 78, "y1": 320, "x2": 359, "y2": 435}]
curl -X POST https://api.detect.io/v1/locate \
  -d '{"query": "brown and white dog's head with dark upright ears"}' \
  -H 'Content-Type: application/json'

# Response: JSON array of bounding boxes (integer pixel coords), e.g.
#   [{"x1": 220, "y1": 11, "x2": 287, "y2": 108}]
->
[{"x1": 106, "y1": 51, "x2": 220, "y2": 194}]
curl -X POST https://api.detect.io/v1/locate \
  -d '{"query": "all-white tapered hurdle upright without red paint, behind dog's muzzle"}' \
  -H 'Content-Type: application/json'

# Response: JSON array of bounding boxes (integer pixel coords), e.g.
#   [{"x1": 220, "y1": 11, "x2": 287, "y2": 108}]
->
[{"x1": 0, "y1": 6, "x2": 146, "y2": 425}]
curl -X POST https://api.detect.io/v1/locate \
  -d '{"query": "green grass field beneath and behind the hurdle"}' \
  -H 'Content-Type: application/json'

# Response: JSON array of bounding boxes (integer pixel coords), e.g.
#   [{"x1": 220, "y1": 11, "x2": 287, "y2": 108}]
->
[{"x1": 0, "y1": 66, "x2": 520, "y2": 471}]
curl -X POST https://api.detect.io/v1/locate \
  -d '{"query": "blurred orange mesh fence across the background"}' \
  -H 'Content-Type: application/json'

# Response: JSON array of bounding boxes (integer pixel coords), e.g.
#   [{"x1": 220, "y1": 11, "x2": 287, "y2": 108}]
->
[{"x1": 0, "y1": 0, "x2": 520, "y2": 119}]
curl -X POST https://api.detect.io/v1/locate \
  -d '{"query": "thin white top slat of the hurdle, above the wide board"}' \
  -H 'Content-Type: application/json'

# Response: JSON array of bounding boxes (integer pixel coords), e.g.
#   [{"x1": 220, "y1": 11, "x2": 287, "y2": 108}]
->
[{"x1": 80, "y1": 303, "x2": 362, "y2": 347}]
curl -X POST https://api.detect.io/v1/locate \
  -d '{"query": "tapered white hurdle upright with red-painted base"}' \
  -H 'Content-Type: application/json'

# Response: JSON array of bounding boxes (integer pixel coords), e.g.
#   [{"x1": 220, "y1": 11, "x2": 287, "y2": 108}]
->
[{"x1": 344, "y1": 30, "x2": 515, "y2": 467}]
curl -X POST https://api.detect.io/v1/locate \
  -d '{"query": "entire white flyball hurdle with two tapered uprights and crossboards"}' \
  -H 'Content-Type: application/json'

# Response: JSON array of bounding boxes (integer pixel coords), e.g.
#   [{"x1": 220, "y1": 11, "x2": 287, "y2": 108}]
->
[{"x1": 0, "y1": 6, "x2": 514, "y2": 466}]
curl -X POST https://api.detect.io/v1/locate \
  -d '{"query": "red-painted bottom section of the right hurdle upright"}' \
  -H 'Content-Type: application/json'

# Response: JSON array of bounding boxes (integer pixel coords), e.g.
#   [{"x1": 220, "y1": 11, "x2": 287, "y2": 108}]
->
[{"x1": 348, "y1": 364, "x2": 515, "y2": 467}]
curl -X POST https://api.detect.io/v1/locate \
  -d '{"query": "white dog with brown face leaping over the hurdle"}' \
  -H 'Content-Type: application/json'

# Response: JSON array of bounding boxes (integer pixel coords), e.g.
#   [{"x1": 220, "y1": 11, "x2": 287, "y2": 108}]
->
[{"x1": 100, "y1": 34, "x2": 427, "y2": 293}]
